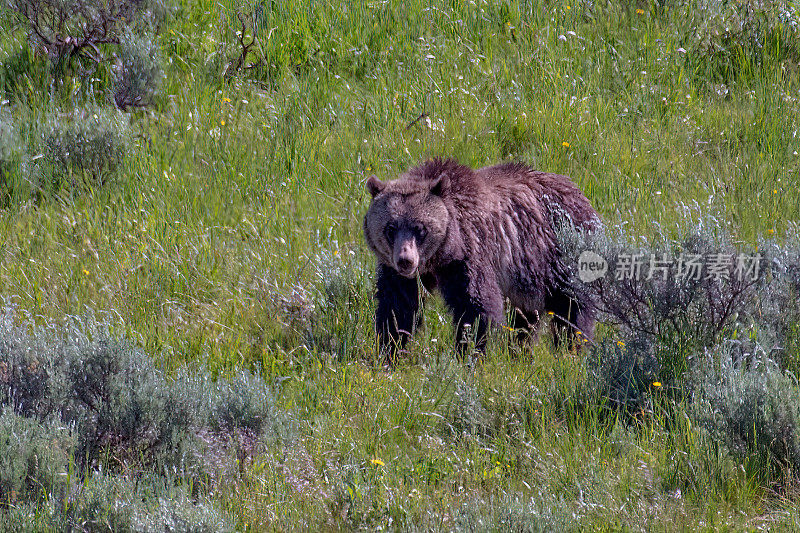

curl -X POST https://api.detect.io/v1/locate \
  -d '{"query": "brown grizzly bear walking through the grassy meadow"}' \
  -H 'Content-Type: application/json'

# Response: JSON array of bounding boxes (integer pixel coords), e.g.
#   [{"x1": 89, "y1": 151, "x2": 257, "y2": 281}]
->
[{"x1": 364, "y1": 159, "x2": 600, "y2": 366}]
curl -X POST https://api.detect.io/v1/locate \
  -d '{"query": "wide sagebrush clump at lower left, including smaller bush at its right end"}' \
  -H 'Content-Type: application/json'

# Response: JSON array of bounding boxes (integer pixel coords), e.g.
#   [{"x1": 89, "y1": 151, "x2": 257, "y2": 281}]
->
[{"x1": 0, "y1": 307, "x2": 291, "y2": 475}]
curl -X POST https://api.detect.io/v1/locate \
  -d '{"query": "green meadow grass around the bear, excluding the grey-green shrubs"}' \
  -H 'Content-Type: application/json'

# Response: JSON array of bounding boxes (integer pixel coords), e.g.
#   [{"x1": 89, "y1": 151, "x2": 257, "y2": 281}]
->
[{"x1": 0, "y1": 0, "x2": 800, "y2": 531}]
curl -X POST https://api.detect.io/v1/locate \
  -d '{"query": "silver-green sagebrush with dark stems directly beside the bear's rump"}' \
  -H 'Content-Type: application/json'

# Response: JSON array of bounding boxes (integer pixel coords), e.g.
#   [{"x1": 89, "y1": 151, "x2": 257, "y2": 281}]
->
[{"x1": 559, "y1": 212, "x2": 785, "y2": 383}]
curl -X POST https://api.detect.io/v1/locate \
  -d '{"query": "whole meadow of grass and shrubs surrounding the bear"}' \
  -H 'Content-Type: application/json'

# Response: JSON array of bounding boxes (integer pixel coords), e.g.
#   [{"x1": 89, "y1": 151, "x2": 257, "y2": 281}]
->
[{"x1": 0, "y1": 0, "x2": 800, "y2": 531}]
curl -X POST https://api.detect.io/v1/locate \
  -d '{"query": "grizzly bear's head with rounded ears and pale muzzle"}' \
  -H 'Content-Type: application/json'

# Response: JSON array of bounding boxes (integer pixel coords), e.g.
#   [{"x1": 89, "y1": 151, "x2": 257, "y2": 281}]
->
[{"x1": 364, "y1": 176, "x2": 450, "y2": 278}]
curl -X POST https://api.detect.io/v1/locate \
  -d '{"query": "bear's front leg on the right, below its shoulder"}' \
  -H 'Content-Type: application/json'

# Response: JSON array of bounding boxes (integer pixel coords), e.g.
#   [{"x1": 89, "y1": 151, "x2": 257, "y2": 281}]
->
[{"x1": 437, "y1": 261, "x2": 505, "y2": 353}]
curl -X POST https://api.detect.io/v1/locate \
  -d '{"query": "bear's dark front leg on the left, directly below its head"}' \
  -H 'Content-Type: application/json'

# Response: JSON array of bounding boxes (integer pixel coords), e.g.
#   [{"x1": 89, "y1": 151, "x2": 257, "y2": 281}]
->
[{"x1": 375, "y1": 263, "x2": 419, "y2": 366}]
